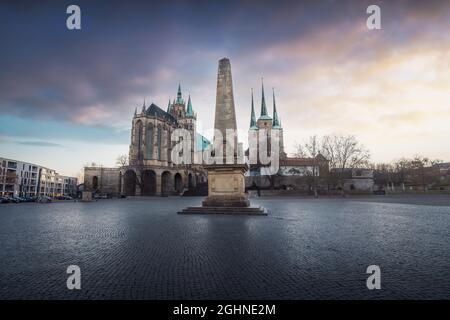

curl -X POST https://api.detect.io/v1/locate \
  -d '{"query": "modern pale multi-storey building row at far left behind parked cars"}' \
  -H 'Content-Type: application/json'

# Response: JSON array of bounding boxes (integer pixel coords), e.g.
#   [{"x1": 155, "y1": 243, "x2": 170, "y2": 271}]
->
[{"x1": 0, "y1": 158, "x2": 77, "y2": 197}]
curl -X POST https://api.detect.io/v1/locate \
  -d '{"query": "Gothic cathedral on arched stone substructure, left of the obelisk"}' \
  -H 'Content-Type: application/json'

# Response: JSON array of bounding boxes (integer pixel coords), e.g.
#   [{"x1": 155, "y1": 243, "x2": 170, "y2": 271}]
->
[{"x1": 84, "y1": 85, "x2": 210, "y2": 196}]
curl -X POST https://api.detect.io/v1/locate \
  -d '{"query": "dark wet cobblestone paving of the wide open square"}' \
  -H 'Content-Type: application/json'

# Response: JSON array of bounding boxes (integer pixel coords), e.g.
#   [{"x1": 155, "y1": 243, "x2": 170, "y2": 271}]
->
[{"x1": 0, "y1": 197, "x2": 450, "y2": 299}]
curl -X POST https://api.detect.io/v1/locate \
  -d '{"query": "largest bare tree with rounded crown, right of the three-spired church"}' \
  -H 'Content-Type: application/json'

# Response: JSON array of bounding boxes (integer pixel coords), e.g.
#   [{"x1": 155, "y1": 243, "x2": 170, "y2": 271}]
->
[{"x1": 321, "y1": 135, "x2": 370, "y2": 196}]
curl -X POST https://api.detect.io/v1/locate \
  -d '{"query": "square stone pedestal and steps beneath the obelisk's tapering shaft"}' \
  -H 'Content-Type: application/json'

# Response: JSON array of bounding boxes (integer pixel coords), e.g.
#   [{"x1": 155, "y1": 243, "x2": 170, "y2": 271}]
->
[{"x1": 178, "y1": 164, "x2": 267, "y2": 215}]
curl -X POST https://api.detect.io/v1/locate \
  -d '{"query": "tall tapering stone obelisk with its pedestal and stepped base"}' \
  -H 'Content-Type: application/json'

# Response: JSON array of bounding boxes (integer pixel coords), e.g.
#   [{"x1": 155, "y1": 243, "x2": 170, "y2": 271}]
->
[{"x1": 179, "y1": 58, "x2": 267, "y2": 215}]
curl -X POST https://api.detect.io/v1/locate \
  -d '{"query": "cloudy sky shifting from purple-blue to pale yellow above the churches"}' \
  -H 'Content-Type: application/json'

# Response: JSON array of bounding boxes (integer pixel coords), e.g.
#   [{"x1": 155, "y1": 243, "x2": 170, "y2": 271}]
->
[{"x1": 0, "y1": 0, "x2": 450, "y2": 176}]
